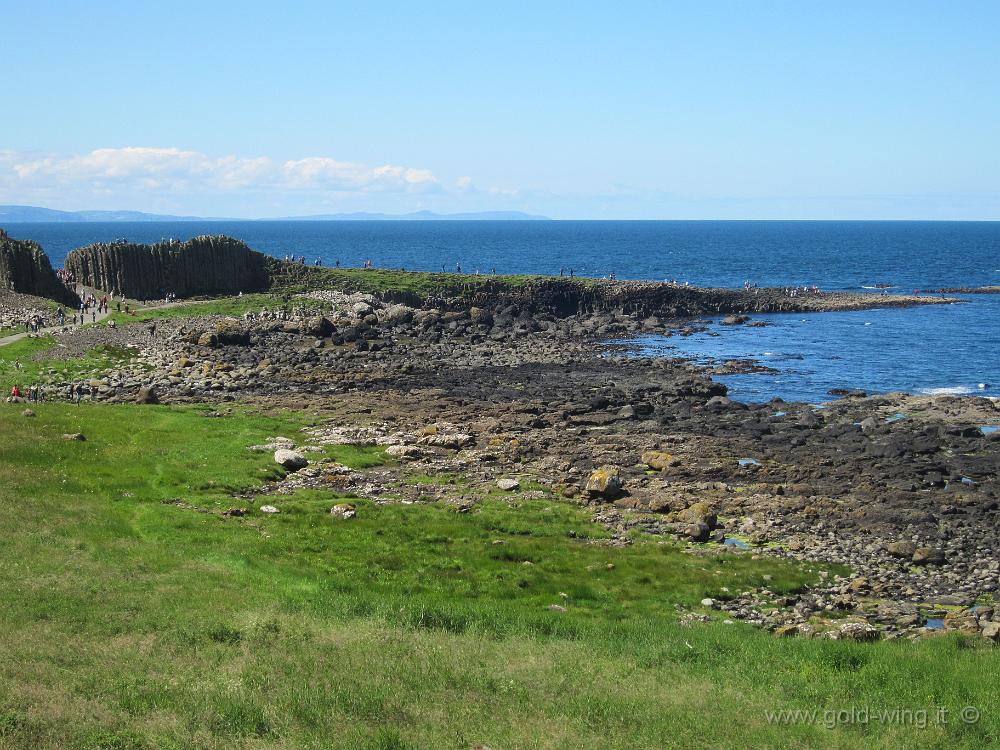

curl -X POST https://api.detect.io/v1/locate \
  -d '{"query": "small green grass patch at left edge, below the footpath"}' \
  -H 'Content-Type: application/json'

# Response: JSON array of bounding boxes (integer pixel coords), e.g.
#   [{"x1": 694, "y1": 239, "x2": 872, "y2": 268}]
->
[{"x1": 0, "y1": 335, "x2": 133, "y2": 396}]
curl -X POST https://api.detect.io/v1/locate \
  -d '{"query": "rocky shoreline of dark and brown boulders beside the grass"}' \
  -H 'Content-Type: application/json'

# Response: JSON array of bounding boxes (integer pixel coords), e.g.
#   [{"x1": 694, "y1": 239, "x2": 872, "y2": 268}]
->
[{"x1": 7, "y1": 291, "x2": 1000, "y2": 640}]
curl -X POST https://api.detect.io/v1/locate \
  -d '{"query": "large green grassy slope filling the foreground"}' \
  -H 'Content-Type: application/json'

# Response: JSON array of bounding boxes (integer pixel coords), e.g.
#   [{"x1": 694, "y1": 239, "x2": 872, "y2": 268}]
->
[{"x1": 0, "y1": 404, "x2": 1000, "y2": 748}]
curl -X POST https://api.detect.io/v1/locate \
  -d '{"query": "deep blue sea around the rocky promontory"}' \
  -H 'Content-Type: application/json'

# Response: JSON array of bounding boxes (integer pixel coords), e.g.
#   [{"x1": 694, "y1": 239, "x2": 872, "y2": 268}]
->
[{"x1": 6, "y1": 221, "x2": 1000, "y2": 403}]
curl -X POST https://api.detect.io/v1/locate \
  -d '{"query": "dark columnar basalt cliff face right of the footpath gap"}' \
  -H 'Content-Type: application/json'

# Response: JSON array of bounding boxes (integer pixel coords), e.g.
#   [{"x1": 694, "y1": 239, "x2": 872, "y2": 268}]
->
[{"x1": 66, "y1": 237, "x2": 275, "y2": 299}]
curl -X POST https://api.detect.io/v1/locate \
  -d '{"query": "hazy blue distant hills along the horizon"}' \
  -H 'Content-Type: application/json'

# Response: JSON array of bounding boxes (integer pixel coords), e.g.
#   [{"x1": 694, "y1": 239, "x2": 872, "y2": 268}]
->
[{"x1": 0, "y1": 206, "x2": 549, "y2": 225}]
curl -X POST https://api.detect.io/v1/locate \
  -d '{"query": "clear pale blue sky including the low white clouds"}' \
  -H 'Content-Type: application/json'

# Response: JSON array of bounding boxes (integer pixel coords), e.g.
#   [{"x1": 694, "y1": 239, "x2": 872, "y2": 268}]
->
[{"x1": 0, "y1": 0, "x2": 1000, "y2": 220}]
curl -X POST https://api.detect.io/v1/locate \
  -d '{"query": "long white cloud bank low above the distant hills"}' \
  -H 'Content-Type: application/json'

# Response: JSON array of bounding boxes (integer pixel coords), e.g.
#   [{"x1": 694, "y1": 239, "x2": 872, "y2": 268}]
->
[{"x1": 0, "y1": 146, "x2": 438, "y2": 193}]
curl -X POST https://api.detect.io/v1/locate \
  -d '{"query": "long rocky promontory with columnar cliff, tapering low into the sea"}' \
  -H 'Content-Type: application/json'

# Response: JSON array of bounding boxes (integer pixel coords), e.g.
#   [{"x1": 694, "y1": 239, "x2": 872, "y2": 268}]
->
[{"x1": 58, "y1": 236, "x2": 954, "y2": 318}]
